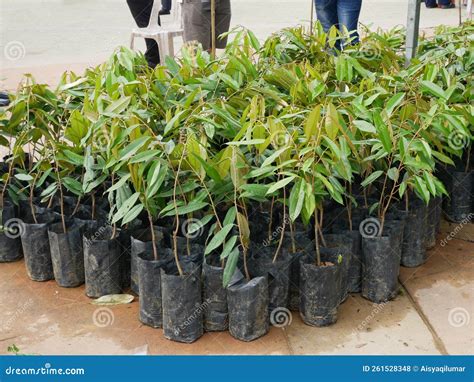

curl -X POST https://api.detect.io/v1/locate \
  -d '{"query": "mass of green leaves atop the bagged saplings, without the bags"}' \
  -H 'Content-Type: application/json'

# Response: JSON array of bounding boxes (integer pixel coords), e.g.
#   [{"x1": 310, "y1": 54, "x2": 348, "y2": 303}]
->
[{"x1": 0, "y1": 22, "x2": 474, "y2": 282}]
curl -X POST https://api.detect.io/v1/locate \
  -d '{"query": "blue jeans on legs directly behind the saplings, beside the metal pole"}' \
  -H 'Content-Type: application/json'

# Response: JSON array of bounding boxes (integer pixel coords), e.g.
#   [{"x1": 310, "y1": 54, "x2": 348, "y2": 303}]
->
[{"x1": 314, "y1": 0, "x2": 362, "y2": 49}]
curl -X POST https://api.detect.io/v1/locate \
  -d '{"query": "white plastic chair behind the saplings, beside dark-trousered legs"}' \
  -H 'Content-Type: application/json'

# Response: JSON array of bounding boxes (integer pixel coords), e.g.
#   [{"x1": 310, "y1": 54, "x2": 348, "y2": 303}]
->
[{"x1": 130, "y1": 0, "x2": 184, "y2": 62}]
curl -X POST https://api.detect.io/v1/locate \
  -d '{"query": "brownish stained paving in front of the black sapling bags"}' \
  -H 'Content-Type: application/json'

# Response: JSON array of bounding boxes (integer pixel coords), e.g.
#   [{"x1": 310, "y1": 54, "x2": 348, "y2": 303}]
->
[{"x1": 0, "y1": 225, "x2": 474, "y2": 354}]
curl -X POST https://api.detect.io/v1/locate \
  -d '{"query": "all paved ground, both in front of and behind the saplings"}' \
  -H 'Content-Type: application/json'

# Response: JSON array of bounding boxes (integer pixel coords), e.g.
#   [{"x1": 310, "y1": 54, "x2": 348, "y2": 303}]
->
[{"x1": 0, "y1": 0, "x2": 474, "y2": 354}]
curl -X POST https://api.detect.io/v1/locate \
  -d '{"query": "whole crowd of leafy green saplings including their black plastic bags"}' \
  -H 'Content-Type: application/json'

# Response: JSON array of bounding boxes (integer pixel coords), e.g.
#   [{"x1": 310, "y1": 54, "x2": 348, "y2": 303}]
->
[{"x1": 0, "y1": 22, "x2": 474, "y2": 343}]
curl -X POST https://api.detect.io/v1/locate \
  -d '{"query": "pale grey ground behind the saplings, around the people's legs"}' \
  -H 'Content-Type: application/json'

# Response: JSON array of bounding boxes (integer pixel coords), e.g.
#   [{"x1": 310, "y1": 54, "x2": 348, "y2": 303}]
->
[{"x1": 0, "y1": 0, "x2": 468, "y2": 89}]
